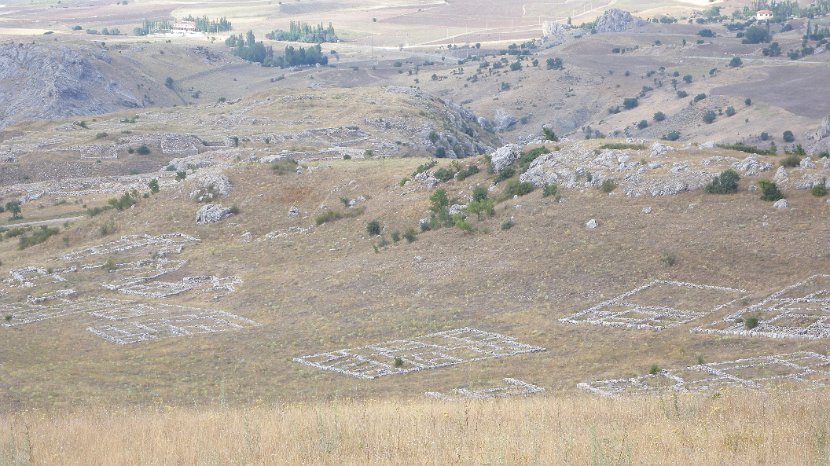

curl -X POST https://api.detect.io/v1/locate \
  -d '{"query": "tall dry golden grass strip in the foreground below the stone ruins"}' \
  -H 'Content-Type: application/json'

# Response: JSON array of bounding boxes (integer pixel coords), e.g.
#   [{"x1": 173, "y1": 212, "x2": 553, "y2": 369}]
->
[{"x1": 0, "y1": 392, "x2": 830, "y2": 465}]
